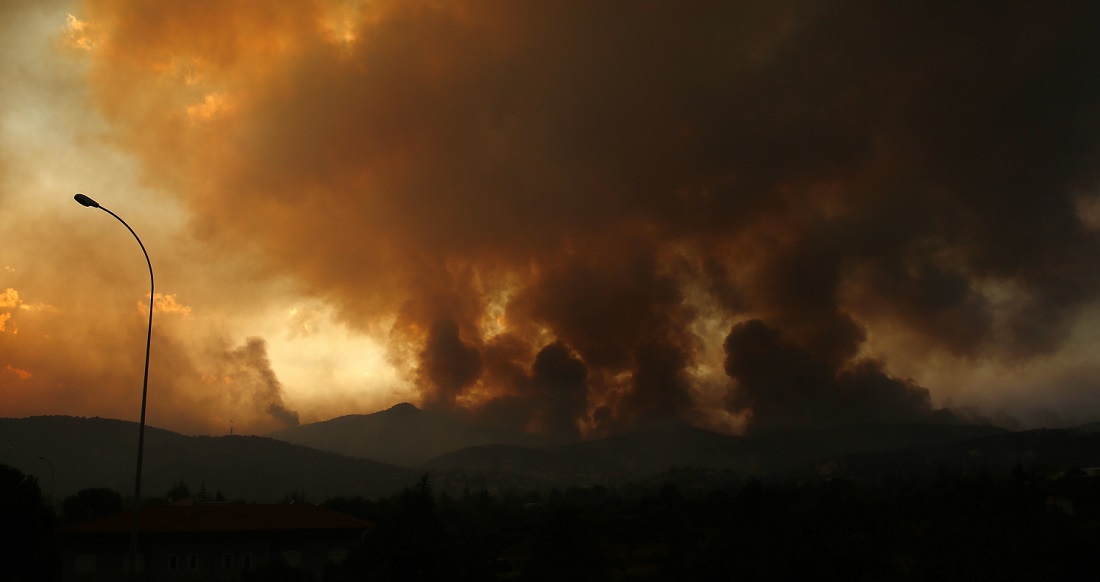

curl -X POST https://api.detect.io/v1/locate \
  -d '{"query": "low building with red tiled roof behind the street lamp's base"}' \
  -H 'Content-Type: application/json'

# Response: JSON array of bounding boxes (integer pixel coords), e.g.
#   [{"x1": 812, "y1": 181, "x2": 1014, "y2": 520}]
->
[{"x1": 58, "y1": 504, "x2": 370, "y2": 582}]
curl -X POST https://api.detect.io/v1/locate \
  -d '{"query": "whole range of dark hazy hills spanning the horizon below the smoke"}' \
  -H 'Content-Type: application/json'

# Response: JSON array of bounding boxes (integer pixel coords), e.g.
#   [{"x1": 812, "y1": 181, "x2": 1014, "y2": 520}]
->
[{"x1": 0, "y1": 405, "x2": 1100, "y2": 501}]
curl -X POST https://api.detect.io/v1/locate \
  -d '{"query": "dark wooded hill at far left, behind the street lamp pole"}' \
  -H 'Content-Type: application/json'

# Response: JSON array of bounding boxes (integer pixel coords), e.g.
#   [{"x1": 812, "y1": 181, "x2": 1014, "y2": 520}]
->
[{"x1": 0, "y1": 416, "x2": 418, "y2": 502}]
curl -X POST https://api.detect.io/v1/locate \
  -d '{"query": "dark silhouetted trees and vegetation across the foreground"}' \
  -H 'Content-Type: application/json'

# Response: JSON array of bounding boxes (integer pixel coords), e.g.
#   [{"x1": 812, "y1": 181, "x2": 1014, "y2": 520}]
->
[{"x1": 0, "y1": 464, "x2": 1100, "y2": 582}]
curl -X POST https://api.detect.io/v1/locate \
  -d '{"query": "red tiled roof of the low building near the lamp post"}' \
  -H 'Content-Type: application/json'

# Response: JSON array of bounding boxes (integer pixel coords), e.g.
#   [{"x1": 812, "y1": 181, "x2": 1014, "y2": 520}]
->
[{"x1": 58, "y1": 504, "x2": 370, "y2": 534}]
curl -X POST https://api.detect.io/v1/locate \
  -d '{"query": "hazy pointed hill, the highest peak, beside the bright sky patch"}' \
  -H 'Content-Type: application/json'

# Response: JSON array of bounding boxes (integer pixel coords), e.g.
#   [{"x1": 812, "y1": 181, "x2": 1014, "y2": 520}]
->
[{"x1": 268, "y1": 403, "x2": 547, "y2": 466}]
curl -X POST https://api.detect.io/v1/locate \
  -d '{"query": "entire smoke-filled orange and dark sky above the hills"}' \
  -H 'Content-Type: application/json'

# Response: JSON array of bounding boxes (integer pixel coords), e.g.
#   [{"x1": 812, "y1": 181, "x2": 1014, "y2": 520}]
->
[{"x1": 0, "y1": 0, "x2": 1100, "y2": 439}]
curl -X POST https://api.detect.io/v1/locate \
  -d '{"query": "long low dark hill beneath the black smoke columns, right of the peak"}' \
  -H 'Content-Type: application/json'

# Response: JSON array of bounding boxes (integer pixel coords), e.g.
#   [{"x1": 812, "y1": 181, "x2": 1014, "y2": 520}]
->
[{"x1": 420, "y1": 424, "x2": 1008, "y2": 490}]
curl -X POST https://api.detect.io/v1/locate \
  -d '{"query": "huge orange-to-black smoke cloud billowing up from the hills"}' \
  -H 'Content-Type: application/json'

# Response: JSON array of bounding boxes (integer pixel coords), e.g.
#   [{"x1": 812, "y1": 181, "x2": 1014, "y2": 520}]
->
[{"x1": 47, "y1": 0, "x2": 1100, "y2": 436}]
